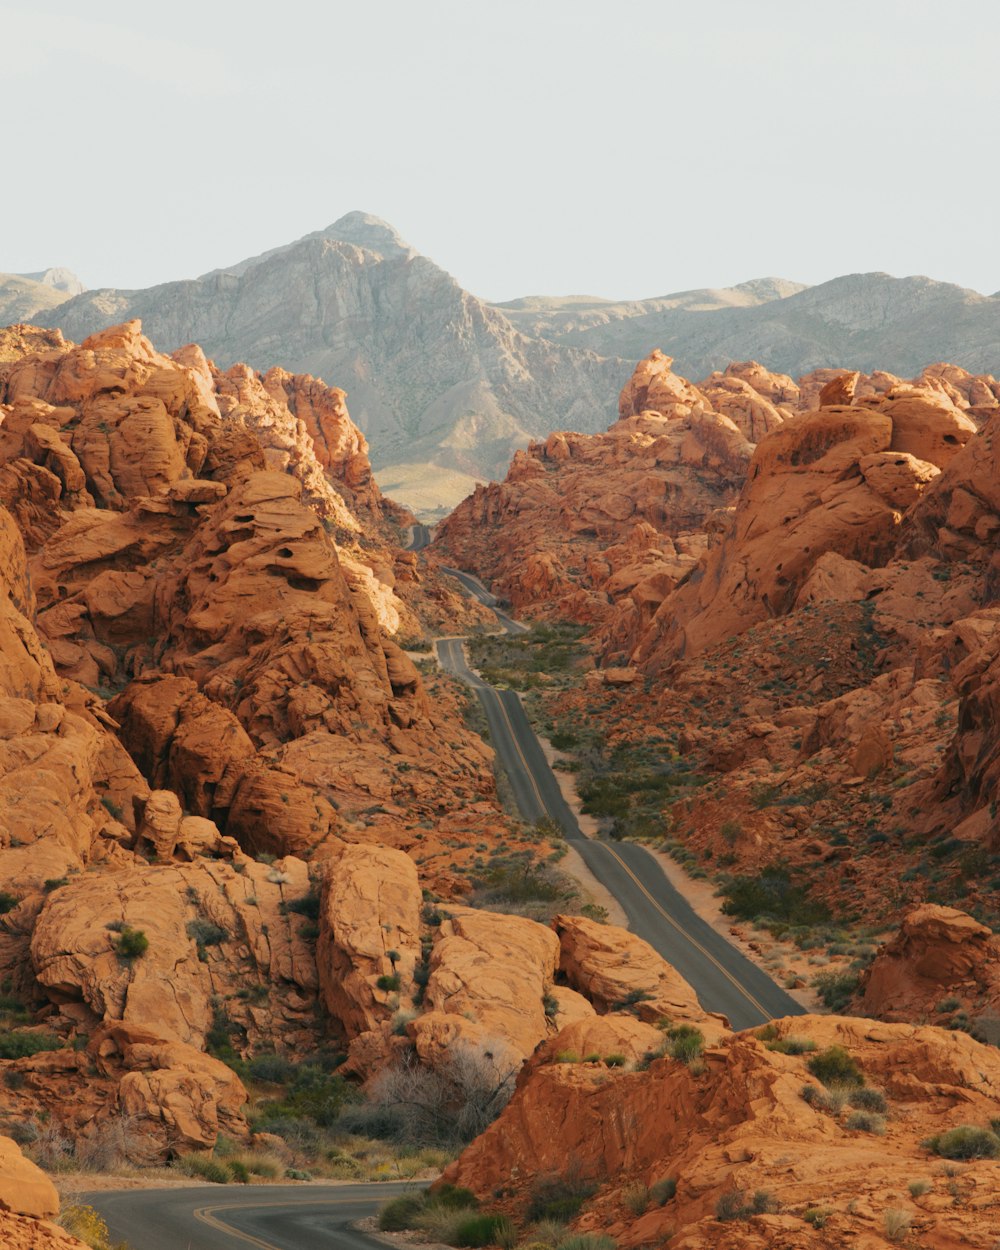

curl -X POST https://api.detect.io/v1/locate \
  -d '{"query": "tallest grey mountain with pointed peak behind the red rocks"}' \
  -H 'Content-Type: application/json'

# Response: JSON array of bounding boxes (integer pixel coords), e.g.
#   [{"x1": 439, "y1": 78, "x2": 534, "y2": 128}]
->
[{"x1": 41, "y1": 213, "x2": 629, "y2": 511}]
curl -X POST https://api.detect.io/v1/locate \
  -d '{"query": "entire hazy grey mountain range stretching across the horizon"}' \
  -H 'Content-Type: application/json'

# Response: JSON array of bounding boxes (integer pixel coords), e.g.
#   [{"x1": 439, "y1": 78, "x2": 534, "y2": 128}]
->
[{"x1": 0, "y1": 213, "x2": 1000, "y2": 516}]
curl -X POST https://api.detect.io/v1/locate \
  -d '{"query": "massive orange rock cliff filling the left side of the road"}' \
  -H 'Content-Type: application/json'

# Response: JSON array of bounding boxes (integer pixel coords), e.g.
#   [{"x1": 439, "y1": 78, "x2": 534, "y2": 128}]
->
[{"x1": 0, "y1": 323, "x2": 547, "y2": 1160}]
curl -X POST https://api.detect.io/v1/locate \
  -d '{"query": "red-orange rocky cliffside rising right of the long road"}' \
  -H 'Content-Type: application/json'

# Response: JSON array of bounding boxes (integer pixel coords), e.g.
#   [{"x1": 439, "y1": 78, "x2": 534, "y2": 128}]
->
[{"x1": 438, "y1": 353, "x2": 1000, "y2": 935}]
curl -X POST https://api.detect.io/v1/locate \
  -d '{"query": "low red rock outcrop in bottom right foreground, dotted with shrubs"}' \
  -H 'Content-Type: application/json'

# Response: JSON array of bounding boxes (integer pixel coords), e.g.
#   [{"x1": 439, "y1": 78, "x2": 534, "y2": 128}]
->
[{"x1": 444, "y1": 1016, "x2": 1000, "y2": 1250}]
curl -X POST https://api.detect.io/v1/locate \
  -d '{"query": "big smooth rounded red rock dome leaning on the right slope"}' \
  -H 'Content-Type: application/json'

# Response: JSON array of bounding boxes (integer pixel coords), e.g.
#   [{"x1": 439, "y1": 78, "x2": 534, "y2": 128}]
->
[{"x1": 640, "y1": 390, "x2": 974, "y2": 664}]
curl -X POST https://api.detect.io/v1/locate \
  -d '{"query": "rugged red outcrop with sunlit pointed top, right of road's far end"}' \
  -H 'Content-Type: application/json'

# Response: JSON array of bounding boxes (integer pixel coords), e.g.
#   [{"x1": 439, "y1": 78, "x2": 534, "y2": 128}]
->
[{"x1": 434, "y1": 353, "x2": 751, "y2": 638}]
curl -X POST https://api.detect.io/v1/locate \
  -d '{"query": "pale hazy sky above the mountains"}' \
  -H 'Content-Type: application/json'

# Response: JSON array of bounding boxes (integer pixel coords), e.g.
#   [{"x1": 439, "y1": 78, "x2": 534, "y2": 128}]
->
[{"x1": 7, "y1": 0, "x2": 1000, "y2": 300}]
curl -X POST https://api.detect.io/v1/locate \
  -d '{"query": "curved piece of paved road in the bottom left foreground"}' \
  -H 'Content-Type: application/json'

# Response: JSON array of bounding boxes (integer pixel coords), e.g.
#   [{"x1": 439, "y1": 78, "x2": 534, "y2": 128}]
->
[{"x1": 78, "y1": 1183, "x2": 419, "y2": 1250}]
